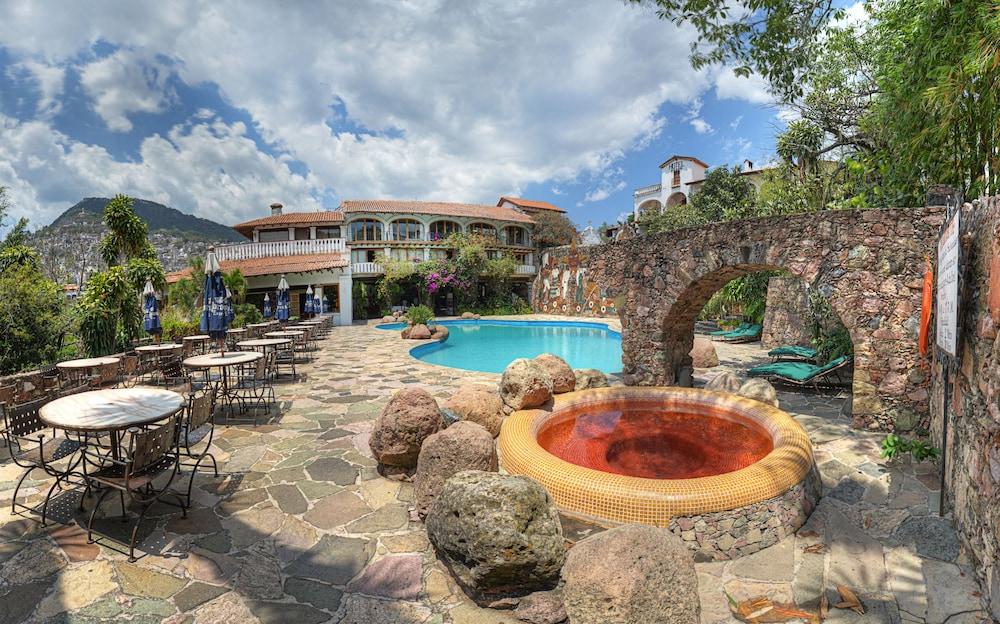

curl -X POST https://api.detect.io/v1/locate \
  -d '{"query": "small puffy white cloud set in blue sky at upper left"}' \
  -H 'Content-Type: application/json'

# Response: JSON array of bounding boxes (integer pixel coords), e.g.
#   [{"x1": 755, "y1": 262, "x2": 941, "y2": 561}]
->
[{"x1": 80, "y1": 49, "x2": 175, "y2": 132}]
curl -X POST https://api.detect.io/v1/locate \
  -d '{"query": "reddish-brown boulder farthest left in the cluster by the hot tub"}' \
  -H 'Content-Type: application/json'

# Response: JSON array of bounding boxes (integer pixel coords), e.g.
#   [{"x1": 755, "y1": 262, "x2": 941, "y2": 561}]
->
[{"x1": 368, "y1": 388, "x2": 444, "y2": 468}]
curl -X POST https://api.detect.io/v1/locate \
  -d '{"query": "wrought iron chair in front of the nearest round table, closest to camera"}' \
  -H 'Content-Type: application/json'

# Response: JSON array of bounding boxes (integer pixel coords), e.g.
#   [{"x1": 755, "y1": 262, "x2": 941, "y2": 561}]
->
[{"x1": 84, "y1": 414, "x2": 187, "y2": 562}]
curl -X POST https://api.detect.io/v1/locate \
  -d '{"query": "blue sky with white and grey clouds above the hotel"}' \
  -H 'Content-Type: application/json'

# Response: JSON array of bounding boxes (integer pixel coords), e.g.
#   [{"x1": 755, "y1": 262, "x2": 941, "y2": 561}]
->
[{"x1": 0, "y1": 0, "x2": 784, "y2": 233}]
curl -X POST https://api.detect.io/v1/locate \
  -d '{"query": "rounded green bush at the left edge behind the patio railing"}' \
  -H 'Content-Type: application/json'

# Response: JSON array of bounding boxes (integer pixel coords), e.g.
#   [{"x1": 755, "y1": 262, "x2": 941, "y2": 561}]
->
[{"x1": 0, "y1": 265, "x2": 67, "y2": 375}]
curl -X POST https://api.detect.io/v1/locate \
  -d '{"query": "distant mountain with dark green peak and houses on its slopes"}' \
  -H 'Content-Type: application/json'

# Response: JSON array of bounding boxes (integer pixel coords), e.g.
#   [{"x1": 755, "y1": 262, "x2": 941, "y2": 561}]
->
[{"x1": 30, "y1": 197, "x2": 246, "y2": 283}]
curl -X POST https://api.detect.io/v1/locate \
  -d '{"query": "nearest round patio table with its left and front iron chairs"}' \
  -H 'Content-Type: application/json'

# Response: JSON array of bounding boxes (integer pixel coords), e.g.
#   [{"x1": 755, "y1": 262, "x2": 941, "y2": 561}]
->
[{"x1": 0, "y1": 386, "x2": 187, "y2": 561}]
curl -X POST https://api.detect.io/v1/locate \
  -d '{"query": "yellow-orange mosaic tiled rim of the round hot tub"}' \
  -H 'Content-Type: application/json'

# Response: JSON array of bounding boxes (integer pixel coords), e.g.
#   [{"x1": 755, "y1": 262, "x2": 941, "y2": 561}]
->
[{"x1": 498, "y1": 386, "x2": 813, "y2": 527}]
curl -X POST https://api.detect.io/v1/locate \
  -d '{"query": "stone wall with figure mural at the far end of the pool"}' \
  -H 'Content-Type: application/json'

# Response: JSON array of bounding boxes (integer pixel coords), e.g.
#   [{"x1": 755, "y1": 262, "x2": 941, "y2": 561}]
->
[{"x1": 531, "y1": 245, "x2": 618, "y2": 317}]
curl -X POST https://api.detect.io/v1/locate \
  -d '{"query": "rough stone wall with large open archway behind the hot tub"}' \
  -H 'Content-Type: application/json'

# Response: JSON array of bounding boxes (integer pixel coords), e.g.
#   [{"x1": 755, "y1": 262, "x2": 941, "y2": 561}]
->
[{"x1": 587, "y1": 207, "x2": 943, "y2": 430}]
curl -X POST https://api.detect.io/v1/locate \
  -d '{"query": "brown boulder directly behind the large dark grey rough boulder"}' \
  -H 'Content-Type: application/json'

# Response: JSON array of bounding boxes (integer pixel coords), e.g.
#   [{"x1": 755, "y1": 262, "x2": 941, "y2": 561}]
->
[{"x1": 413, "y1": 422, "x2": 499, "y2": 518}]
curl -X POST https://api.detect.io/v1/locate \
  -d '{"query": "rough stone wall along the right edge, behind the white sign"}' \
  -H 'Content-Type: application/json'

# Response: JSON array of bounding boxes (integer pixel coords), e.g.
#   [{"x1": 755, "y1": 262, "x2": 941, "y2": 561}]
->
[{"x1": 931, "y1": 197, "x2": 1000, "y2": 620}]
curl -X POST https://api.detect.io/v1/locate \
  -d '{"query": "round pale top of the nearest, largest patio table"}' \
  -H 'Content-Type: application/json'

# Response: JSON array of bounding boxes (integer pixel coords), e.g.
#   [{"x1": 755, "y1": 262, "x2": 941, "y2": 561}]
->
[{"x1": 38, "y1": 386, "x2": 184, "y2": 431}]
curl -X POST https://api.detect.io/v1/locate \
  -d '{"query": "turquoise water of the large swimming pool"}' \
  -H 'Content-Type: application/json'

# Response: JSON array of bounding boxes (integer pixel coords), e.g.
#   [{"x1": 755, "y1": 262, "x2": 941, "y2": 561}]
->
[{"x1": 402, "y1": 320, "x2": 622, "y2": 373}]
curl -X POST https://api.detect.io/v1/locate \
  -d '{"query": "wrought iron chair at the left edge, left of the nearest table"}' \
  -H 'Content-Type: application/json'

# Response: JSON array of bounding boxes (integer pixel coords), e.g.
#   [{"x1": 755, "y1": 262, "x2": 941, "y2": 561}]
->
[{"x1": 0, "y1": 398, "x2": 84, "y2": 526}]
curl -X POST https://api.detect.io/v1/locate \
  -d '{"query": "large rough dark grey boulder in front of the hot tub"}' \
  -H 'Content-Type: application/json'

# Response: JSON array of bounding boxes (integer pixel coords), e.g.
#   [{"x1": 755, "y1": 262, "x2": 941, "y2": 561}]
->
[{"x1": 427, "y1": 470, "x2": 566, "y2": 600}]
